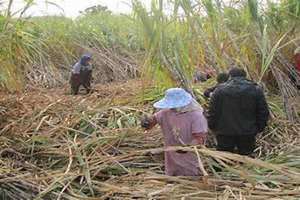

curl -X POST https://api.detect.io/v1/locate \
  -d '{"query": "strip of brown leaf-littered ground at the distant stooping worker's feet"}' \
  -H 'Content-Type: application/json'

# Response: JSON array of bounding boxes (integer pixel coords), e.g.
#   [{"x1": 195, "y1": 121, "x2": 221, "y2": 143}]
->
[{"x1": 0, "y1": 80, "x2": 143, "y2": 130}]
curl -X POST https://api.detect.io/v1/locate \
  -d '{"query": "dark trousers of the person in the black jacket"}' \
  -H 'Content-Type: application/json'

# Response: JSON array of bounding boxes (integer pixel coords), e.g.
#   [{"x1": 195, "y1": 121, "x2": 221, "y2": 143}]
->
[{"x1": 217, "y1": 135, "x2": 256, "y2": 155}]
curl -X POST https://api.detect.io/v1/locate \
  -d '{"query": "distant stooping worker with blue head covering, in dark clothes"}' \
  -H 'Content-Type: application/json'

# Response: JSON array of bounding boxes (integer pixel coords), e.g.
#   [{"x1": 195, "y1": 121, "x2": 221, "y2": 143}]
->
[{"x1": 70, "y1": 54, "x2": 92, "y2": 95}]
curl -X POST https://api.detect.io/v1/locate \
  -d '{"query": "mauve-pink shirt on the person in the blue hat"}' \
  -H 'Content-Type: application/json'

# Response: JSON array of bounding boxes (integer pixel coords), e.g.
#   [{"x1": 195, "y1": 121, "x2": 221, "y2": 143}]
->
[{"x1": 155, "y1": 110, "x2": 208, "y2": 176}]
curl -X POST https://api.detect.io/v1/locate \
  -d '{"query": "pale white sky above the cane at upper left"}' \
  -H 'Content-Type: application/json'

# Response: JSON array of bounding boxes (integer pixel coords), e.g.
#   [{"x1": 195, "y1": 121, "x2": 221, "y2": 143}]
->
[{"x1": 4, "y1": 0, "x2": 151, "y2": 17}]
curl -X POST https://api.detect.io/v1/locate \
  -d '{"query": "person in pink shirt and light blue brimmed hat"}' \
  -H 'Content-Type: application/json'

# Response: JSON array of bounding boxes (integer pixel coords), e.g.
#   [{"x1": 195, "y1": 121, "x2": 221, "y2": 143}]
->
[{"x1": 141, "y1": 88, "x2": 208, "y2": 176}]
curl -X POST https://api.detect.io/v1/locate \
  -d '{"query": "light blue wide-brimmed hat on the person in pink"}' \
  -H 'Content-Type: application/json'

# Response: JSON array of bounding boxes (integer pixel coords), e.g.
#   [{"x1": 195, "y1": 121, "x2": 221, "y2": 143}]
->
[{"x1": 153, "y1": 88, "x2": 193, "y2": 109}]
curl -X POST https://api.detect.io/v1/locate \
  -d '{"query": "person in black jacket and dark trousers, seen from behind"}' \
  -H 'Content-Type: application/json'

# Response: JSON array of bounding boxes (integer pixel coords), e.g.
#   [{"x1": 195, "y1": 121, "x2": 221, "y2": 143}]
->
[{"x1": 208, "y1": 68, "x2": 269, "y2": 155}]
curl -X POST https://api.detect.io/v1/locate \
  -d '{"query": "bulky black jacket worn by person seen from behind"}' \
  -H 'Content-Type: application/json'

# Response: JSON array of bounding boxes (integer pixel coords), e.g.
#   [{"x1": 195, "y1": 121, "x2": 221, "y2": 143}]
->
[{"x1": 207, "y1": 77, "x2": 269, "y2": 135}]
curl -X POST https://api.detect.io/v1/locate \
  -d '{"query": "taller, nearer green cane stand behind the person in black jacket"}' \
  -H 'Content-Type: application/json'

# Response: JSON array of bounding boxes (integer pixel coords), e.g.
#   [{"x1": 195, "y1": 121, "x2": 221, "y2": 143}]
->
[{"x1": 134, "y1": 0, "x2": 300, "y2": 87}]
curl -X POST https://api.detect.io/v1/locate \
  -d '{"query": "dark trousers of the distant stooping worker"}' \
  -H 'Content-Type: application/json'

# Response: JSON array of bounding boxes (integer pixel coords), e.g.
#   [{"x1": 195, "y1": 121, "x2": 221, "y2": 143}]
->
[{"x1": 70, "y1": 72, "x2": 91, "y2": 95}]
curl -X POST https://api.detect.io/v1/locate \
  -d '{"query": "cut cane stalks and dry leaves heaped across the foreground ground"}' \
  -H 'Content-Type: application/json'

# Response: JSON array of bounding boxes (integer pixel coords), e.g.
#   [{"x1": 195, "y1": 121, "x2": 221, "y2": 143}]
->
[{"x1": 0, "y1": 82, "x2": 300, "y2": 200}]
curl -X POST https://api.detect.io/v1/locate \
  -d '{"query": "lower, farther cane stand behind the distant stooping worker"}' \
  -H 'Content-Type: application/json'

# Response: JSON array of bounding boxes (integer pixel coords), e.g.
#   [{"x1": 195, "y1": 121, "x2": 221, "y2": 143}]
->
[{"x1": 0, "y1": 1, "x2": 140, "y2": 91}]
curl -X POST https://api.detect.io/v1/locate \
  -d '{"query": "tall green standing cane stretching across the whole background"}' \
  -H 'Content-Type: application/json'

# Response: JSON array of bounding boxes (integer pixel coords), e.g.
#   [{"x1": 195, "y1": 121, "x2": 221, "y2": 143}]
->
[{"x1": 0, "y1": 0, "x2": 300, "y2": 91}]
